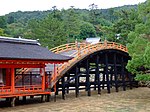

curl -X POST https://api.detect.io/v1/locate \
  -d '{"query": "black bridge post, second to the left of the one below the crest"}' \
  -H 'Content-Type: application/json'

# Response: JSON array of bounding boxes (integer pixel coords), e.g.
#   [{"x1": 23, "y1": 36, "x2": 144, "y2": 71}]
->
[{"x1": 86, "y1": 59, "x2": 91, "y2": 96}]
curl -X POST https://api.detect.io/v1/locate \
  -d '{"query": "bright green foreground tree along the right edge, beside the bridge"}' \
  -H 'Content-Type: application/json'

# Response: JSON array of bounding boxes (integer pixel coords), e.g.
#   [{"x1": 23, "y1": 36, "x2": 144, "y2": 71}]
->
[{"x1": 127, "y1": 0, "x2": 150, "y2": 81}]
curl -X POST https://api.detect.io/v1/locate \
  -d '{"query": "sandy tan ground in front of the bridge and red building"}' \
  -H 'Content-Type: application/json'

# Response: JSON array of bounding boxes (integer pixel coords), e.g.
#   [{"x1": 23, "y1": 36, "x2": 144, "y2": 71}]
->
[{"x1": 0, "y1": 88, "x2": 150, "y2": 112}]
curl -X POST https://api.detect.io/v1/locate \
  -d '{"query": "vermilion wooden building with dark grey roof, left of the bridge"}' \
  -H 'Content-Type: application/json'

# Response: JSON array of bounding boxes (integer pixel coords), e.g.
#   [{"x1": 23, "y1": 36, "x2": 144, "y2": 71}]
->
[{"x1": 0, "y1": 37, "x2": 70, "y2": 106}]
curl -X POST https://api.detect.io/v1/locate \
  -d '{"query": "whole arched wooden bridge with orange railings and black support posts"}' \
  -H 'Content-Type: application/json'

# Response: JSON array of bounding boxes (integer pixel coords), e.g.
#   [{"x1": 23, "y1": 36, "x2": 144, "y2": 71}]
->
[{"x1": 47, "y1": 41, "x2": 134, "y2": 99}]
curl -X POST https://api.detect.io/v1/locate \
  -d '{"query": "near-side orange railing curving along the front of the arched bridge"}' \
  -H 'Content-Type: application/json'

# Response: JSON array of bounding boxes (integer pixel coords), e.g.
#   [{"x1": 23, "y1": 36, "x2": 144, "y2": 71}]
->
[{"x1": 51, "y1": 41, "x2": 128, "y2": 88}]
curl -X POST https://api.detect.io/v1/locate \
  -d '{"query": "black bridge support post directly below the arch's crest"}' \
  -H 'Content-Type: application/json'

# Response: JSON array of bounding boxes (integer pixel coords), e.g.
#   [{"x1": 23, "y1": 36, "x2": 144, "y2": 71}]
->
[{"x1": 105, "y1": 53, "x2": 110, "y2": 93}]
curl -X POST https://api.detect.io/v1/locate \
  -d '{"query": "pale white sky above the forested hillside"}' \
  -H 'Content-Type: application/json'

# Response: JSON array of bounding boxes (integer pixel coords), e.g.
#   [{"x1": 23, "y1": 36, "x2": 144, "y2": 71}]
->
[{"x1": 0, "y1": 0, "x2": 146, "y2": 15}]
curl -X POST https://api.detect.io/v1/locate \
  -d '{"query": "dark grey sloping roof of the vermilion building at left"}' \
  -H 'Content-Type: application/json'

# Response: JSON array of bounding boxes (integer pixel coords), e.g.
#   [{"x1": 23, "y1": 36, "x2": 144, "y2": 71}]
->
[{"x1": 0, "y1": 37, "x2": 71, "y2": 61}]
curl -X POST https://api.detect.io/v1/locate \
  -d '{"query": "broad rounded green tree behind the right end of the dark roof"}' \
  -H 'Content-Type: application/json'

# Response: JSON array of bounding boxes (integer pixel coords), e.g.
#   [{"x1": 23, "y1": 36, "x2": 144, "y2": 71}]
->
[{"x1": 25, "y1": 15, "x2": 67, "y2": 48}]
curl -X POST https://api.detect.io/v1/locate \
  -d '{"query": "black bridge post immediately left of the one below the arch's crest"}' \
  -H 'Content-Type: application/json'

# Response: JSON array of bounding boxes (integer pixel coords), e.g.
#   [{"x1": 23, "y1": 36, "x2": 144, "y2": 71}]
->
[{"x1": 96, "y1": 55, "x2": 101, "y2": 94}]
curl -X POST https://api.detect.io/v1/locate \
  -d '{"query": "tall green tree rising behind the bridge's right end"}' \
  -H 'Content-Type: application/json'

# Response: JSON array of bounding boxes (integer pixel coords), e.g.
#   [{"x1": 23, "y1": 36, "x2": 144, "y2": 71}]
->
[{"x1": 113, "y1": 9, "x2": 139, "y2": 45}]
